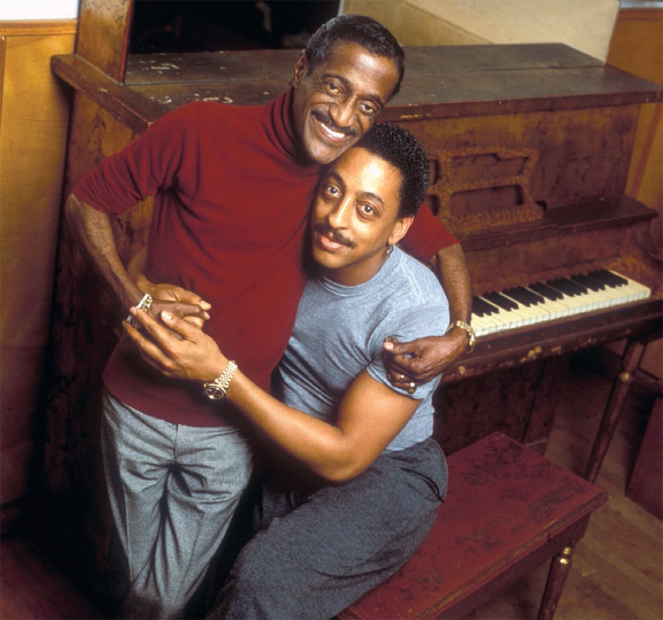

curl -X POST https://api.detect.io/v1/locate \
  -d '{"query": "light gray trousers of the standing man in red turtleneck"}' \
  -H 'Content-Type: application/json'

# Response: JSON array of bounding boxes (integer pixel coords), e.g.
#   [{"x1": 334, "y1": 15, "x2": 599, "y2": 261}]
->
[{"x1": 102, "y1": 394, "x2": 252, "y2": 619}]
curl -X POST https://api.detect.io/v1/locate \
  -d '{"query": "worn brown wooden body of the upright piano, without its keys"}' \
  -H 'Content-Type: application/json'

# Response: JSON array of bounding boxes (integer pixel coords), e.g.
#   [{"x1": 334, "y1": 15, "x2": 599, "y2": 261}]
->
[{"x1": 44, "y1": 0, "x2": 663, "y2": 594}]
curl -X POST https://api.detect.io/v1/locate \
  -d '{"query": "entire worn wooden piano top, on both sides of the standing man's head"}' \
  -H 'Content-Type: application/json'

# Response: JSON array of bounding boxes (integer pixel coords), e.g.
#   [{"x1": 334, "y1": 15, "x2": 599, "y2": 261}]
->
[{"x1": 53, "y1": 43, "x2": 661, "y2": 134}]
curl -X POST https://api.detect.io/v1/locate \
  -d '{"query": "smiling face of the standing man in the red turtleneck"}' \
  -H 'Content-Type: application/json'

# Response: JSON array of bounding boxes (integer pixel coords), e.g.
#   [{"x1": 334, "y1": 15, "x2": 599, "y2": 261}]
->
[{"x1": 292, "y1": 41, "x2": 398, "y2": 164}]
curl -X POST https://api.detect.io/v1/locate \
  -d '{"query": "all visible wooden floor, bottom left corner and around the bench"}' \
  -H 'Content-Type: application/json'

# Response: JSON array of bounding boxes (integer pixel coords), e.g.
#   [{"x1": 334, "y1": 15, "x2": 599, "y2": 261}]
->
[{"x1": 0, "y1": 355, "x2": 663, "y2": 620}]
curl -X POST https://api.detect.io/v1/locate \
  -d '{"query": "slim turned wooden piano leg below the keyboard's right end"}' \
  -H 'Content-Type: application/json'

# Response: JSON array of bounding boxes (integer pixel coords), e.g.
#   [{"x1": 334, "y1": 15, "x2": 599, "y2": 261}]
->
[{"x1": 585, "y1": 340, "x2": 646, "y2": 482}]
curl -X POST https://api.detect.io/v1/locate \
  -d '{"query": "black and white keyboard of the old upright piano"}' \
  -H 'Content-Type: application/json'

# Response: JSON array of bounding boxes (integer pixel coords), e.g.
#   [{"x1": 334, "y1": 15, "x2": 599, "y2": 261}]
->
[{"x1": 472, "y1": 270, "x2": 651, "y2": 337}]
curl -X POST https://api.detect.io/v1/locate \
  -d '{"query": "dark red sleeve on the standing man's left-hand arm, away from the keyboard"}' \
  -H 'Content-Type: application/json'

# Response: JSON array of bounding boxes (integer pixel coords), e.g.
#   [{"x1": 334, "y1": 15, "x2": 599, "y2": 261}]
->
[{"x1": 73, "y1": 104, "x2": 202, "y2": 216}]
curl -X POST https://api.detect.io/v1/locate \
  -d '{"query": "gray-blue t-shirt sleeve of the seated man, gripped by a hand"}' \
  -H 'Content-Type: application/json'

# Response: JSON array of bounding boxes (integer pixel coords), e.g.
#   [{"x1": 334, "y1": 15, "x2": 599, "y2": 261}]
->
[{"x1": 366, "y1": 302, "x2": 449, "y2": 400}]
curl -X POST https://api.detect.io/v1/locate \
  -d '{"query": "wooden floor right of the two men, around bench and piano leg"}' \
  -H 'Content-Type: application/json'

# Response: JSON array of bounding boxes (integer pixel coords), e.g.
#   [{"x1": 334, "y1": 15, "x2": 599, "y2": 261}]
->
[{"x1": 470, "y1": 355, "x2": 663, "y2": 620}]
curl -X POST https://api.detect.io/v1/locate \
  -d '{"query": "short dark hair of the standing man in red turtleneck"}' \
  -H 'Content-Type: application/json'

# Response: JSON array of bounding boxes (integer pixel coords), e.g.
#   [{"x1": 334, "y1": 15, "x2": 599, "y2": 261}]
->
[{"x1": 304, "y1": 14, "x2": 405, "y2": 97}]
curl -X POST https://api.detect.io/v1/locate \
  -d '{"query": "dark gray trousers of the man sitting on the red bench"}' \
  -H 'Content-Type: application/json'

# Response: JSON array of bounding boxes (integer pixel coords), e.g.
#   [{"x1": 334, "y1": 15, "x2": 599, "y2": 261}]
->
[{"x1": 209, "y1": 439, "x2": 447, "y2": 620}]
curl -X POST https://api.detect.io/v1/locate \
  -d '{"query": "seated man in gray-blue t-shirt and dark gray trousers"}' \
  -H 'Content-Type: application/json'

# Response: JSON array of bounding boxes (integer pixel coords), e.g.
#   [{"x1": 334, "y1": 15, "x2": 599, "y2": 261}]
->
[{"x1": 125, "y1": 124, "x2": 448, "y2": 620}]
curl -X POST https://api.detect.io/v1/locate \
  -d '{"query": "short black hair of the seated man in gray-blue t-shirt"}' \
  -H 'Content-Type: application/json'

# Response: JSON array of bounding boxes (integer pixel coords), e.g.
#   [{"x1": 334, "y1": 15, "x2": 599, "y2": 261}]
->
[{"x1": 355, "y1": 123, "x2": 430, "y2": 218}]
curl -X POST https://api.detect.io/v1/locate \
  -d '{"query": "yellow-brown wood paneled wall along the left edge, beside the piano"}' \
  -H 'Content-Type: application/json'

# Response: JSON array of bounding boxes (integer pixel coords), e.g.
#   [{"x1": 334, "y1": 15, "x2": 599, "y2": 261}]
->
[{"x1": 0, "y1": 20, "x2": 77, "y2": 533}]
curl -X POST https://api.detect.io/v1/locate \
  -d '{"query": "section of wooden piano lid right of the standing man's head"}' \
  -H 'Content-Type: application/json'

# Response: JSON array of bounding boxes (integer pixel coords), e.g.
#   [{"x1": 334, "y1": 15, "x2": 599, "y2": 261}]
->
[{"x1": 384, "y1": 43, "x2": 662, "y2": 120}]
